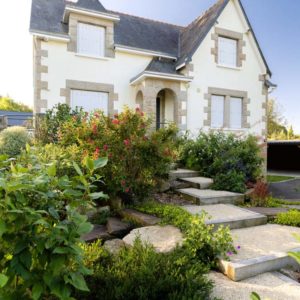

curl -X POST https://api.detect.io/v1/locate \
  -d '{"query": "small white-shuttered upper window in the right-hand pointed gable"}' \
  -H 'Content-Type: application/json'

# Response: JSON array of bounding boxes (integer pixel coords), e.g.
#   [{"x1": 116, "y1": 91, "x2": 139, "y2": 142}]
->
[{"x1": 218, "y1": 37, "x2": 237, "y2": 67}]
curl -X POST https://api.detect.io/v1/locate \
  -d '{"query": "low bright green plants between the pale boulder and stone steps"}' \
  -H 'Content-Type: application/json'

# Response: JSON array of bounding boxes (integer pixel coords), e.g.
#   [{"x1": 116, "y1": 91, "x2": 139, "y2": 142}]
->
[{"x1": 135, "y1": 201, "x2": 235, "y2": 267}]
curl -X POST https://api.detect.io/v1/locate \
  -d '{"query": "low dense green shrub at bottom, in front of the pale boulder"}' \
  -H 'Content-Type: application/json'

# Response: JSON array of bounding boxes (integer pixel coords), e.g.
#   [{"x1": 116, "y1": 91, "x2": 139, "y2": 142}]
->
[{"x1": 75, "y1": 239, "x2": 212, "y2": 300}]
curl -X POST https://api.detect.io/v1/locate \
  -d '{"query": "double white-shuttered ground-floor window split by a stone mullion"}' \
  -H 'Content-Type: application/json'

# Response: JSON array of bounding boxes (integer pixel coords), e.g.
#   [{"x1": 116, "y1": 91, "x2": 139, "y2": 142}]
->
[{"x1": 211, "y1": 95, "x2": 243, "y2": 129}]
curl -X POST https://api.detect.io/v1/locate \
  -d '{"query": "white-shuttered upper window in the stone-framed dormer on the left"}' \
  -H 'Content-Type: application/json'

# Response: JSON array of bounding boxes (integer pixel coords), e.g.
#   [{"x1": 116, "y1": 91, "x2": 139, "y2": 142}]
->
[{"x1": 77, "y1": 23, "x2": 105, "y2": 57}]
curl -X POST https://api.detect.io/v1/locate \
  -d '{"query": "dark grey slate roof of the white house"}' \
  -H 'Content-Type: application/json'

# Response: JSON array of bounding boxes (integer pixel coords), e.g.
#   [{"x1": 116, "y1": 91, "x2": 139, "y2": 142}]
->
[{"x1": 30, "y1": 0, "x2": 271, "y2": 74}]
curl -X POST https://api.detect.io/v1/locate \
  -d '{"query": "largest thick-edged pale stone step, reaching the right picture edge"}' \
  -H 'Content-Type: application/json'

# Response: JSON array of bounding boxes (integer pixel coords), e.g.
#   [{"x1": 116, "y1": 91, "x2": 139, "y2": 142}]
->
[{"x1": 219, "y1": 224, "x2": 300, "y2": 281}]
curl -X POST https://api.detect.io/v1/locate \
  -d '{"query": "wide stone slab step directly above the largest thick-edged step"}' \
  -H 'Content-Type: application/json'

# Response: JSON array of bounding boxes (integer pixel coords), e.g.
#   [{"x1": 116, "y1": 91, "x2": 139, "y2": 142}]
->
[{"x1": 183, "y1": 204, "x2": 268, "y2": 229}]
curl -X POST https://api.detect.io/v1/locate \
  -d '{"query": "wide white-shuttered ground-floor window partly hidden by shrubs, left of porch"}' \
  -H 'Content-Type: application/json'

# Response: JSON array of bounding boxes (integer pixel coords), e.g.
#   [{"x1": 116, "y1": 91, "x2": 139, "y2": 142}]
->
[{"x1": 71, "y1": 90, "x2": 108, "y2": 115}]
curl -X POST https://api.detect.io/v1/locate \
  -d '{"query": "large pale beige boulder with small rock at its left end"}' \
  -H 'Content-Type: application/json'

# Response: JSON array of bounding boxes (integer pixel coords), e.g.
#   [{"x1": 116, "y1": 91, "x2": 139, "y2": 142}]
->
[{"x1": 123, "y1": 225, "x2": 183, "y2": 253}]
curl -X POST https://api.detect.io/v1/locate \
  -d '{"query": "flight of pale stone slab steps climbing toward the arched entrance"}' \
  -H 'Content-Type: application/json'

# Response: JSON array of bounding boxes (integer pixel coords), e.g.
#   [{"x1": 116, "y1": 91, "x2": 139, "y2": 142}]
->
[{"x1": 170, "y1": 169, "x2": 300, "y2": 281}]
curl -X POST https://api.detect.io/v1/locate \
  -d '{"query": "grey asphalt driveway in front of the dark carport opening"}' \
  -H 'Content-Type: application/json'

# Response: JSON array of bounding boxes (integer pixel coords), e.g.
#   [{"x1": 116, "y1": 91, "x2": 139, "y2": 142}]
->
[{"x1": 269, "y1": 179, "x2": 300, "y2": 201}]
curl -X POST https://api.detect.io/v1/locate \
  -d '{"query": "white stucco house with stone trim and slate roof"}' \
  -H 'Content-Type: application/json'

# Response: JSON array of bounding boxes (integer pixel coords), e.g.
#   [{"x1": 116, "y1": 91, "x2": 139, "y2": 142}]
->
[{"x1": 30, "y1": 0, "x2": 274, "y2": 139}]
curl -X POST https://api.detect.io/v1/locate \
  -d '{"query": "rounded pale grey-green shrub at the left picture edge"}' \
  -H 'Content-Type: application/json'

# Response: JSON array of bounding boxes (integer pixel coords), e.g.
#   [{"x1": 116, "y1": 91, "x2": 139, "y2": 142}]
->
[{"x1": 0, "y1": 126, "x2": 31, "y2": 157}]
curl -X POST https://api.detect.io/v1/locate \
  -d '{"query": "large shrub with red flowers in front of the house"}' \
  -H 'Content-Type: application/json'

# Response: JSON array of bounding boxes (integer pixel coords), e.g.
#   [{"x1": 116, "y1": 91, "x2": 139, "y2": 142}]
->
[{"x1": 58, "y1": 108, "x2": 177, "y2": 200}]
